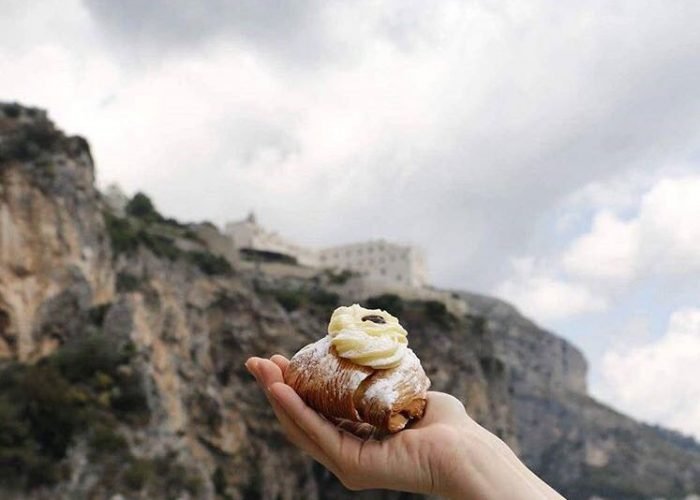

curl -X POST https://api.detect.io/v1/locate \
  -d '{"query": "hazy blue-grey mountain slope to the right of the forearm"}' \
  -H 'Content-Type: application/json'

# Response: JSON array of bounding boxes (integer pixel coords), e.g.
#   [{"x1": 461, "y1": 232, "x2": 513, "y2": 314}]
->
[{"x1": 460, "y1": 292, "x2": 700, "y2": 499}]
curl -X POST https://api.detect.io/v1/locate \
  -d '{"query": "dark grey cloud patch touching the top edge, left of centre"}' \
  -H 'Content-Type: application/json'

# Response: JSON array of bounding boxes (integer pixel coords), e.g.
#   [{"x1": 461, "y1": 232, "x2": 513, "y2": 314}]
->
[{"x1": 83, "y1": 0, "x2": 336, "y2": 61}]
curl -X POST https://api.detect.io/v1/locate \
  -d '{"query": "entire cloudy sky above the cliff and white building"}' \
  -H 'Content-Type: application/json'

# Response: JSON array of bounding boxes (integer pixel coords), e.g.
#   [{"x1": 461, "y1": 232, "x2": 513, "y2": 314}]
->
[{"x1": 0, "y1": 0, "x2": 700, "y2": 437}]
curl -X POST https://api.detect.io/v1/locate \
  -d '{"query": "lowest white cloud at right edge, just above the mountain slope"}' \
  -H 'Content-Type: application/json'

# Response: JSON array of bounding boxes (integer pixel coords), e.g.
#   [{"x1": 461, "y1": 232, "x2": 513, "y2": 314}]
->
[{"x1": 602, "y1": 308, "x2": 700, "y2": 439}]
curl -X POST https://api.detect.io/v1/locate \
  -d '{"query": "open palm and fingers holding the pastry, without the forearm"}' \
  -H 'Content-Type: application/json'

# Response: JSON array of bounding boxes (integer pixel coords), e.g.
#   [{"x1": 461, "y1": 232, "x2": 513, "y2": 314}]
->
[{"x1": 246, "y1": 355, "x2": 474, "y2": 493}]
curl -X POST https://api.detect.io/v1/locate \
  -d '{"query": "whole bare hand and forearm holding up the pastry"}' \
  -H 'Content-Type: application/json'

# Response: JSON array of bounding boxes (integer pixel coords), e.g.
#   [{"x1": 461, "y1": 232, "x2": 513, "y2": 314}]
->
[{"x1": 246, "y1": 355, "x2": 563, "y2": 500}]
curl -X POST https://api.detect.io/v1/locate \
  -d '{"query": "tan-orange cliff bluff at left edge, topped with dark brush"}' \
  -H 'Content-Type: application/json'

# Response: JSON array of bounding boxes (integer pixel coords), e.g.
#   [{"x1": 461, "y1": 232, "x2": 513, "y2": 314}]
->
[{"x1": 0, "y1": 106, "x2": 113, "y2": 360}]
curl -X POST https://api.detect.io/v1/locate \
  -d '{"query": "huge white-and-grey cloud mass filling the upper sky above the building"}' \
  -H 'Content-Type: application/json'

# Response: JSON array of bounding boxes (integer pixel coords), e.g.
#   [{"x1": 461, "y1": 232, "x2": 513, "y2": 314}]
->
[{"x1": 0, "y1": 0, "x2": 700, "y2": 291}]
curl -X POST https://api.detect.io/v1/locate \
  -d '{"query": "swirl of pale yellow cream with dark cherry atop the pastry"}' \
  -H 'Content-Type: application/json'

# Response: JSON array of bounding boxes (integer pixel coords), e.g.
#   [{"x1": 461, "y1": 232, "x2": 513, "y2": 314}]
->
[{"x1": 328, "y1": 304, "x2": 408, "y2": 369}]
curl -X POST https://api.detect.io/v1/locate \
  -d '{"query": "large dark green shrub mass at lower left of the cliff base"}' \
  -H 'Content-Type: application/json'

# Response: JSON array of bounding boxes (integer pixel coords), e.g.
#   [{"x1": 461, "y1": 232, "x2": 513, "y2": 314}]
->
[{"x1": 0, "y1": 334, "x2": 147, "y2": 490}]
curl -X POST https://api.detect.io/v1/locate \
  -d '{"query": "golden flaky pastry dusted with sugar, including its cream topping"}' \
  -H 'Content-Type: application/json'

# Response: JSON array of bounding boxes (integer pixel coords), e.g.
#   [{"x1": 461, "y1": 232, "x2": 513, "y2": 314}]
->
[{"x1": 285, "y1": 304, "x2": 430, "y2": 437}]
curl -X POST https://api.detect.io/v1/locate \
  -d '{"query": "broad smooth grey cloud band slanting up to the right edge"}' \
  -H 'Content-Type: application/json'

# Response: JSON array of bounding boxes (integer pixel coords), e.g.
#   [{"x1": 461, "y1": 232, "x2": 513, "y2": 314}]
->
[{"x1": 314, "y1": 13, "x2": 700, "y2": 288}]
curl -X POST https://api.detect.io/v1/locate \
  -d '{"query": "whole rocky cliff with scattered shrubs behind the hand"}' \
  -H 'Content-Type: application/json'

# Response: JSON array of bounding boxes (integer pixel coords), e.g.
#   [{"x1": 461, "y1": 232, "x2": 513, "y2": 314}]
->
[{"x1": 0, "y1": 104, "x2": 700, "y2": 499}]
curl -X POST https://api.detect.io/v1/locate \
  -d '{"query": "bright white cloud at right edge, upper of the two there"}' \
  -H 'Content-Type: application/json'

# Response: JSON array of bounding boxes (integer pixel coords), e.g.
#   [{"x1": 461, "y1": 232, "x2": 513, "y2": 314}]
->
[{"x1": 494, "y1": 174, "x2": 700, "y2": 322}]
